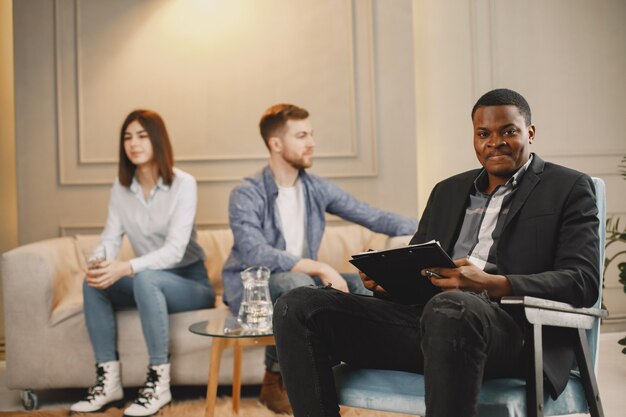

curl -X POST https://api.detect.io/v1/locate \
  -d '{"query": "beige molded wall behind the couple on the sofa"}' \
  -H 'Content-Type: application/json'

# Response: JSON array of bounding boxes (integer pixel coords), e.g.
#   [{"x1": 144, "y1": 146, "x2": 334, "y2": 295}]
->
[{"x1": 9, "y1": 0, "x2": 417, "y2": 243}]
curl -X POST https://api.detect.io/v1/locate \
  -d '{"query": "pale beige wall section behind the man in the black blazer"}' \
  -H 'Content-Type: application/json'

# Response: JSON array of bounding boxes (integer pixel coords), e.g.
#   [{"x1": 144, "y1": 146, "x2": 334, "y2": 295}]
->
[{"x1": 413, "y1": 0, "x2": 626, "y2": 318}]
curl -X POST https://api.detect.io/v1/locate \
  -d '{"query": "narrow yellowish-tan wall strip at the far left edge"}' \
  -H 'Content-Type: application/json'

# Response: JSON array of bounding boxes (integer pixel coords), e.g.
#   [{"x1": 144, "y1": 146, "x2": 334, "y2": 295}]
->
[{"x1": 0, "y1": 1, "x2": 18, "y2": 340}]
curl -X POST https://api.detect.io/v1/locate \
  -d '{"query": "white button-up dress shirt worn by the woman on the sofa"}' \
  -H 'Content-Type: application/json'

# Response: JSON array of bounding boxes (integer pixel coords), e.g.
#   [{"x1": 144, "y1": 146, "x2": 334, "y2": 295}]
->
[{"x1": 95, "y1": 168, "x2": 206, "y2": 273}]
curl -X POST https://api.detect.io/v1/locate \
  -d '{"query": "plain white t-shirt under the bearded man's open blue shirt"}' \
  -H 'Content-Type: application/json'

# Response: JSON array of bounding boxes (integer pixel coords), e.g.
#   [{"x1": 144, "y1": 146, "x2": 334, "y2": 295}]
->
[{"x1": 276, "y1": 180, "x2": 308, "y2": 257}]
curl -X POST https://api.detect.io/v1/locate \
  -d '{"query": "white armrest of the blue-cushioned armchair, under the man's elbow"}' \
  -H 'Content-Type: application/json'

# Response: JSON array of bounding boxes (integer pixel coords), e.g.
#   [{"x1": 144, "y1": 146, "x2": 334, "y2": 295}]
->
[{"x1": 500, "y1": 296, "x2": 608, "y2": 329}]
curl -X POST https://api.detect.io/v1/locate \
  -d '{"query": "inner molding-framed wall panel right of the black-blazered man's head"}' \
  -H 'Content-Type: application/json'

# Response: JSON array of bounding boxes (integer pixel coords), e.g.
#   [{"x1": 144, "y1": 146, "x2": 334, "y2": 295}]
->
[{"x1": 485, "y1": 0, "x2": 626, "y2": 164}]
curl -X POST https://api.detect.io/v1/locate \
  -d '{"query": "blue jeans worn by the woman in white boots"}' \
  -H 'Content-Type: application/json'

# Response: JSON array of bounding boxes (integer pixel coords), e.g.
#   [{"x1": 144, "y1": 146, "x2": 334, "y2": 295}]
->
[{"x1": 83, "y1": 261, "x2": 215, "y2": 365}]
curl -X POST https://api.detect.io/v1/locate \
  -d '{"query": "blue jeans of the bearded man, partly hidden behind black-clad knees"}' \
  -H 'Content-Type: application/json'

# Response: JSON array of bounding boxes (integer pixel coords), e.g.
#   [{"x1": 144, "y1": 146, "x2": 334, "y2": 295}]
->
[{"x1": 265, "y1": 272, "x2": 372, "y2": 372}]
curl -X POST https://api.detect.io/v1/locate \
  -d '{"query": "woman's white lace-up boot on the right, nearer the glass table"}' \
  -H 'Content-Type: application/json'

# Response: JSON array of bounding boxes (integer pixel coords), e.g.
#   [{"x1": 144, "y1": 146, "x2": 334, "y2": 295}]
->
[{"x1": 124, "y1": 363, "x2": 172, "y2": 417}]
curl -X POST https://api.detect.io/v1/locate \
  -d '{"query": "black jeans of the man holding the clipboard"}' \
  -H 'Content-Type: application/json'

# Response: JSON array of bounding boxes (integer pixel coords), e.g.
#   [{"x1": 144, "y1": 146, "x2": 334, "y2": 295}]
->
[{"x1": 274, "y1": 287, "x2": 523, "y2": 417}]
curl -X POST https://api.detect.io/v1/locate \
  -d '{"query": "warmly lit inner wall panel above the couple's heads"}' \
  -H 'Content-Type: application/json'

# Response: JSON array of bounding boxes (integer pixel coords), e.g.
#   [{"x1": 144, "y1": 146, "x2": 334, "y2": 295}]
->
[{"x1": 73, "y1": 0, "x2": 354, "y2": 159}]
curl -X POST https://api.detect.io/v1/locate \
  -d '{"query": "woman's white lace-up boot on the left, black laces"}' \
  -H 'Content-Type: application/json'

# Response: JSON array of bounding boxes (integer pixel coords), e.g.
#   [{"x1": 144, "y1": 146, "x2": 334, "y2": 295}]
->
[{"x1": 70, "y1": 361, "x2": 124, "y2": 413}]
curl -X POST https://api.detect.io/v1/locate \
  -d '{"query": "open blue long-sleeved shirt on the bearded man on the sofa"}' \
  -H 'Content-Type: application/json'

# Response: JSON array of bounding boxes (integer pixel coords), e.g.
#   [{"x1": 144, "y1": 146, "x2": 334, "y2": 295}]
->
[{"x1": 222, "y1": 166, "x2": 418, "y2": 314}]
